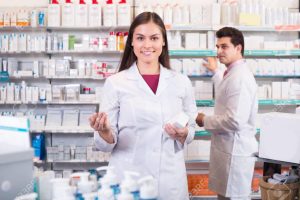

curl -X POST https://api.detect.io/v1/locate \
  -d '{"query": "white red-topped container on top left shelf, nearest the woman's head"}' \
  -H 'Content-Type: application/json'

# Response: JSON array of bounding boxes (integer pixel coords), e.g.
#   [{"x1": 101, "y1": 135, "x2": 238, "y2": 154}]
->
[{"x1": 118, "y1": 0, "x2": 131, "y2": 26}]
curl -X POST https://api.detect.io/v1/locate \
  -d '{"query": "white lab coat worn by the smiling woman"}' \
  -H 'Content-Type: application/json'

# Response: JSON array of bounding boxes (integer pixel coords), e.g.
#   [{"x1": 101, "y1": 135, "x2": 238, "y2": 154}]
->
[{"x1": 94, "y1": 64, "x2": 197, "y2": 200}]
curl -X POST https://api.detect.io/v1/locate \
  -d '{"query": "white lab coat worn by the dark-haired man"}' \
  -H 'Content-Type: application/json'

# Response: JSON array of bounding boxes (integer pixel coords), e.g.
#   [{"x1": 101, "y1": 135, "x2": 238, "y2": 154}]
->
[{"x1": 204, "y1": 62, "x2": 258, "y2": 198}]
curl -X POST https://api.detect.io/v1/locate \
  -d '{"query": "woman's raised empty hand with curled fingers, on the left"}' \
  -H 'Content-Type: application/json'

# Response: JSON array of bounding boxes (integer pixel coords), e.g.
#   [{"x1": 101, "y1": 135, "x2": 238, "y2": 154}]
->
[{"x1": 89, "y1": 112, "x2": 114, "y2": 144}]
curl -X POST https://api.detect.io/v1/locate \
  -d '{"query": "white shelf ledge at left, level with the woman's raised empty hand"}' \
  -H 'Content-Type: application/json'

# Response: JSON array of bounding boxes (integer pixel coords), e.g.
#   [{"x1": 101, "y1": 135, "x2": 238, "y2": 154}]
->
[{"x1": 30, "y1": 126, "x2": 94, "y2": 134}]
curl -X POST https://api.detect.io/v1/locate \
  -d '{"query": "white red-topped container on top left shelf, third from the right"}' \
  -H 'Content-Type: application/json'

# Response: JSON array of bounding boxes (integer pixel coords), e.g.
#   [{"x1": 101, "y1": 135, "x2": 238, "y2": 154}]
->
[{"x1": 88, "y1": 0, "x2": 102, "y2": 27}]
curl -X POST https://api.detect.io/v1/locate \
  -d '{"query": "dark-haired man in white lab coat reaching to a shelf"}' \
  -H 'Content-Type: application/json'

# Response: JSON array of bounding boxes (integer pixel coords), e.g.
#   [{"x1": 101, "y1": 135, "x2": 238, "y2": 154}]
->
[{"x1": 196, "y1": 27, "x2": 258, "y2": 200}]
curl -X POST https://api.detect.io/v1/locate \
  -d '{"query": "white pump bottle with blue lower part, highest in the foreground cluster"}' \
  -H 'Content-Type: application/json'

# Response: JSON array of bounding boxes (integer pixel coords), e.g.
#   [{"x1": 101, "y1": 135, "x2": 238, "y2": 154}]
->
[{"x1": 96, "y1": 166, "x2": 120, "y2": 196}]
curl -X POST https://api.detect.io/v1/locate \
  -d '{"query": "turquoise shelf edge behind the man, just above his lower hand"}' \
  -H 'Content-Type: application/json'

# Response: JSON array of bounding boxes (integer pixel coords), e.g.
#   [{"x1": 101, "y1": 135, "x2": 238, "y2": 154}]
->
[{"x1": 196, "y1": 99, "x2": 300, "y2": 107}]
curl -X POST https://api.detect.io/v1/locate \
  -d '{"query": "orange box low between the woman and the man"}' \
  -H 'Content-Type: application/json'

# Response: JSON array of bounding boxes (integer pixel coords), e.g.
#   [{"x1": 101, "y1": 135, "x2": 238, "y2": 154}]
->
[{"x1": 187, "y1": 174, "x2": 217, "y2": 196}]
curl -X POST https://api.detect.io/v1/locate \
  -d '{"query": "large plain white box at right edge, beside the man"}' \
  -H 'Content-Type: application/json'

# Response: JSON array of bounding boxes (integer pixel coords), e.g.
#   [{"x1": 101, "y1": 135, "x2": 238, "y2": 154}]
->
[{"x1": 259, "y1": 112, "x2": 300, "y2": 164}]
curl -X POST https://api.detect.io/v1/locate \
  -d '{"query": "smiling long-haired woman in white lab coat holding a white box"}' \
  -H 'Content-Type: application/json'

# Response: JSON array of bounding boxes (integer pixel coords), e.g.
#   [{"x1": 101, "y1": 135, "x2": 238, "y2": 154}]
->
[{"x1": 90, "y1": 12, "x2": 197, "y2": 200}]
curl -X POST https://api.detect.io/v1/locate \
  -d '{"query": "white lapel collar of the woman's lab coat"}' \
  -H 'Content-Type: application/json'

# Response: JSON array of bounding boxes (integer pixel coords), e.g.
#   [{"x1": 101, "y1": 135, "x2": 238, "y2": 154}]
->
[{"x1": 127, "y1": 62, "x2": 174, "y2": 96}]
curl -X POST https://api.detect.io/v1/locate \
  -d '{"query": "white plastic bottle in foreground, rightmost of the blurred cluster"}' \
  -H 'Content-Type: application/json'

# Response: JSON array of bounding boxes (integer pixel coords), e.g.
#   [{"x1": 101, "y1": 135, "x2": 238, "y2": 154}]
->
[{"x1": 138, "y1": 176, "x2": 158, "y2": 200}]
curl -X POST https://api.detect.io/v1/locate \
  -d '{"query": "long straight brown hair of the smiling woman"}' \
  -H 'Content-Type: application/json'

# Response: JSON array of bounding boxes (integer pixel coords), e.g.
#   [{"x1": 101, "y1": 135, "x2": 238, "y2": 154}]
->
[{"x1": 119, "y1": 12, "x2": 170, "y2": 72}]
